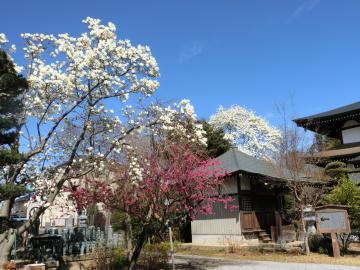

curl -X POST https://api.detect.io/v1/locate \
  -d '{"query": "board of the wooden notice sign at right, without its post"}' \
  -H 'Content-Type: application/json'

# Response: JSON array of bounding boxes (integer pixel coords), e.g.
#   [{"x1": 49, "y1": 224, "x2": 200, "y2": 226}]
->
[{"x1": 316, "y1": 207, "x2": 351, "y2": 233}]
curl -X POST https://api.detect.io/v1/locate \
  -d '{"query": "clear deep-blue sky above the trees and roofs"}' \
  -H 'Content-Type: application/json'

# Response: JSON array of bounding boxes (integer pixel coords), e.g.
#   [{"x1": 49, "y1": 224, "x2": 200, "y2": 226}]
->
[{"x1": 0, "y1": 0, "x2": 360, "y2": 124}]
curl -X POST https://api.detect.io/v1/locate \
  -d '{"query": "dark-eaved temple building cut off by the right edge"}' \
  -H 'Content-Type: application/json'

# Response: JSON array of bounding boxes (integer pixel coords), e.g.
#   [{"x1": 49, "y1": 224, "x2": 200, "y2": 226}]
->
[{"x1": 294, "y1": 102, "x2": 360, "y2": 185}]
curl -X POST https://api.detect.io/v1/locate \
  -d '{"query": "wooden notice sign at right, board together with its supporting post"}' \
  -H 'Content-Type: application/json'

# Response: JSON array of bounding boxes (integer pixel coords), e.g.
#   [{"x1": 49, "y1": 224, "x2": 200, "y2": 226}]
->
[{"x1": 315, "y1": 205, "x2": 351, "y2": 258}]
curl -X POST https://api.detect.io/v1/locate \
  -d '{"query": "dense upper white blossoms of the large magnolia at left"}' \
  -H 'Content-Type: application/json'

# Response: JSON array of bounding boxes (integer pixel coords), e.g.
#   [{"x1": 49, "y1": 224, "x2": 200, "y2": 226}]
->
[{"x1": 22, "y1": 18, "x2": 159, "y2": 121}]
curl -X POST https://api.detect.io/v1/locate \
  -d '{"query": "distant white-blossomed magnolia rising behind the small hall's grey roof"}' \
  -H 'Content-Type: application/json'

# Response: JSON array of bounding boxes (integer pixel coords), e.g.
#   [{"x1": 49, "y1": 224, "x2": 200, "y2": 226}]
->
[{"x1": 210, "y1": 105, "x2": 281, "y2": 159}]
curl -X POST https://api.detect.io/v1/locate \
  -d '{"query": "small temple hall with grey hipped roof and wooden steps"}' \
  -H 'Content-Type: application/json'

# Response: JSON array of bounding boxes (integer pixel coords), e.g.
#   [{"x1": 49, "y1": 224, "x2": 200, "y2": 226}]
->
[{"x1": 191, "y1": 149, "x2": 304, "y2": 245}]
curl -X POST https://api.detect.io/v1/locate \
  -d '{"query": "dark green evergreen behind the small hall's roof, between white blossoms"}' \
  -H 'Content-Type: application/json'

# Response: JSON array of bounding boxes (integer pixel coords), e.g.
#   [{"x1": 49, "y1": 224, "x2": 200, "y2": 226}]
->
[{"x1": 200, "y1": 120, "x2": 232, "y2": 157}]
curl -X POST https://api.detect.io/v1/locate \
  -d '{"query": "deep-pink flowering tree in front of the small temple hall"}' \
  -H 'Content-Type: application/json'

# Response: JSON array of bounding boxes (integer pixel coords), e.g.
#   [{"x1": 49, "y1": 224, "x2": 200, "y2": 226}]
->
[{"x1": 66, "y1": 142, "x2": 233, "y2": 269}]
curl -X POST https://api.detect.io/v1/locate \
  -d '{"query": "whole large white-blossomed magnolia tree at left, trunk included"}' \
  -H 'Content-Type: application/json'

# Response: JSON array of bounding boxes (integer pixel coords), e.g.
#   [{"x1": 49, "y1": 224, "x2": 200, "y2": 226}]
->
[{"x1": 0, "y1": 18, "x2": 206, "y2": 266}]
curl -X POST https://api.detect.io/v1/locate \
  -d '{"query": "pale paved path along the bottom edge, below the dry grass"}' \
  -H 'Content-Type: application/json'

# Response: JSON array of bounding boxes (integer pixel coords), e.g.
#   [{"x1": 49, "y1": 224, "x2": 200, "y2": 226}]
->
[{"x1": 175, "y1": 255, "x2": 360, "y2": 270}]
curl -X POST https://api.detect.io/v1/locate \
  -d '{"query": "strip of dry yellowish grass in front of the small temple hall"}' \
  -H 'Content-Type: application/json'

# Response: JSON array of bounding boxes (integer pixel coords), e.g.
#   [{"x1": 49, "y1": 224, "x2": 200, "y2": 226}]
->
[{"x1": 176, "y1": 245, "x2": 360, "y2": 266}]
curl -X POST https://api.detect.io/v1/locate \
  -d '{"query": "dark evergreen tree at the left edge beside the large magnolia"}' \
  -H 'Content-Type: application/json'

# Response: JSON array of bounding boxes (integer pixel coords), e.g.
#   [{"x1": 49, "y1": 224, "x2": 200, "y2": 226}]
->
[{"x1": 0, "y1": 49, "x2": 27, "y2": 166}]
